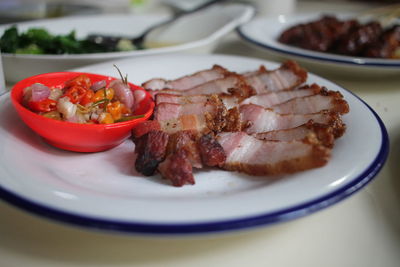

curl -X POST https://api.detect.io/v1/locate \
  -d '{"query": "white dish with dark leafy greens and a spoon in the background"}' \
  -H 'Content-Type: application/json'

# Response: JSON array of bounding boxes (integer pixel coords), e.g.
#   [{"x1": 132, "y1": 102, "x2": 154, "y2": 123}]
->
[{"x1": 0, "y1": 4, "x2": 254, "y2": 83}]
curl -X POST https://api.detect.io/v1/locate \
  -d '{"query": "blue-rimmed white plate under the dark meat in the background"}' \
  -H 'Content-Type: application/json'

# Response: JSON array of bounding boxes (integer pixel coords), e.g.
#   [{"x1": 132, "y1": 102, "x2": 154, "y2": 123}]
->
[{"x1": 237, "y1": 14, "x2": 400, "y2": 77}]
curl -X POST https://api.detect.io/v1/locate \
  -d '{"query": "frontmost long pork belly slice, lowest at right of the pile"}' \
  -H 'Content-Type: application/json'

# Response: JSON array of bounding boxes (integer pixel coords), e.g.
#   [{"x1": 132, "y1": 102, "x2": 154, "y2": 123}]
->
[{"x1": 217, "y1": 132, "x2": 330, "y2": 175}]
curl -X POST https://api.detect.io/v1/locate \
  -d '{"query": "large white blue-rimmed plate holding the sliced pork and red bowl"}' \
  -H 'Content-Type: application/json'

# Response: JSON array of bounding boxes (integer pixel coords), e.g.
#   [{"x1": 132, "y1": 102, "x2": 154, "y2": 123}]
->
[{"x1": 0, "y1": 55, "x2": 388, "y2": 234}]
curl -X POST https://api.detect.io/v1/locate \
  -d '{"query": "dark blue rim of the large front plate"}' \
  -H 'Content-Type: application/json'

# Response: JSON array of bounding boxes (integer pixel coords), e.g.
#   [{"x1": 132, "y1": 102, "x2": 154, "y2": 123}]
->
[{"x1": 0, "y1": 75, "x2": 389, "y2": 235}]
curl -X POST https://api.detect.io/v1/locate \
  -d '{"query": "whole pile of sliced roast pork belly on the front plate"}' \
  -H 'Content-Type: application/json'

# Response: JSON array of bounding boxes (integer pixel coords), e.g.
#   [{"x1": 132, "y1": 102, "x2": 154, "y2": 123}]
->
[{"x1": 133, "y1": 61, "x2": 349, "y2": 186}]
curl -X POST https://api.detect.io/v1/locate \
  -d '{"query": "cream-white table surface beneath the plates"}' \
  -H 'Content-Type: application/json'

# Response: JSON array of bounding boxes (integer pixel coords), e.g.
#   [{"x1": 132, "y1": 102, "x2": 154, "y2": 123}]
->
[{"x1": 0, "y1": 2, "x2": 400, "y2": 267}]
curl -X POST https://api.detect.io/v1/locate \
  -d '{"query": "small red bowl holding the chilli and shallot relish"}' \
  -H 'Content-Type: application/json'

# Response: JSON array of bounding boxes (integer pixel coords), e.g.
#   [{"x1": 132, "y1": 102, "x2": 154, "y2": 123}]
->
[{"x1": 11, "y1": 72, "x2": 154, "y2": 152}]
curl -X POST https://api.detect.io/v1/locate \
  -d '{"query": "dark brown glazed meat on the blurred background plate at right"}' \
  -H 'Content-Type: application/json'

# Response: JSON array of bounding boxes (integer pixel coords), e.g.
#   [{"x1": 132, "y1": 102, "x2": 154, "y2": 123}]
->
[{"x1": 278, "y1": 15, "x2": 400, "y2": 58}]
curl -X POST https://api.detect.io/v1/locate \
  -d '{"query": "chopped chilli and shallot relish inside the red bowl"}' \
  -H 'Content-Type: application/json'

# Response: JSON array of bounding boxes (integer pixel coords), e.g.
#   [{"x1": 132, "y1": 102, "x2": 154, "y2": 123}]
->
[{"x1": 23, "y1": 75, "x2": 145, "y2": 124}]
